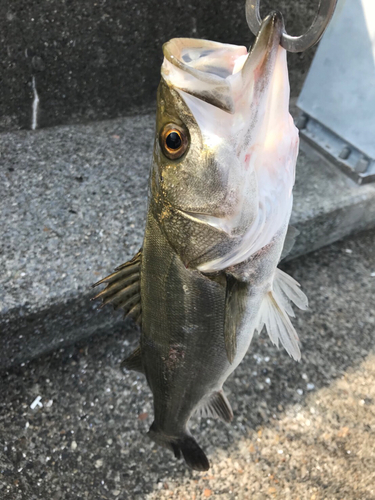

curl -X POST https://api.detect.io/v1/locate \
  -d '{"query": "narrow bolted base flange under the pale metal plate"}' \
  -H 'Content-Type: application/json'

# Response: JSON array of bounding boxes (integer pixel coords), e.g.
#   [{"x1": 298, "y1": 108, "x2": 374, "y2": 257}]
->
[{"x1": 296, "y1": 112, "x2": 375, "y2": 184}]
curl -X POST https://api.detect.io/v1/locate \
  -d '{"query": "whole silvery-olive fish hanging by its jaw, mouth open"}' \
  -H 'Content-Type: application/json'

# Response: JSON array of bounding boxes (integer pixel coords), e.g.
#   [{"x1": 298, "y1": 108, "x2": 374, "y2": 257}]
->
[{"x1": 95, "y1": 12, "x2": 308, "y2": 471}]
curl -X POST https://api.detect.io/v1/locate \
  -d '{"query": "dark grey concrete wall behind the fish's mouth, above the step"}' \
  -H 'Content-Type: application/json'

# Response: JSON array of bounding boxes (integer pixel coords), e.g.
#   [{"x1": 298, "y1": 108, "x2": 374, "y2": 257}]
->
[{"x1": 0, "y1": 0, "x2": 318, "y2": 131}]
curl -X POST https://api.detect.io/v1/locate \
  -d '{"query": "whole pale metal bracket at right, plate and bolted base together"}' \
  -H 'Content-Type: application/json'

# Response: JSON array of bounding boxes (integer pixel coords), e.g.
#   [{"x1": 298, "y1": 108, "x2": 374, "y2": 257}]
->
[{"x1": 297, "y1": 0, "x2": 375, "y2": 184}]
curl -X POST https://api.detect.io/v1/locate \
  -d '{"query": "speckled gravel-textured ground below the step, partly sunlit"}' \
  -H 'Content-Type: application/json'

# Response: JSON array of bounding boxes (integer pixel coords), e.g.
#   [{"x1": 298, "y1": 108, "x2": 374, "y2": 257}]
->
[{"x1": 0, "y1": 231, "x2": 375, "y2": 500}]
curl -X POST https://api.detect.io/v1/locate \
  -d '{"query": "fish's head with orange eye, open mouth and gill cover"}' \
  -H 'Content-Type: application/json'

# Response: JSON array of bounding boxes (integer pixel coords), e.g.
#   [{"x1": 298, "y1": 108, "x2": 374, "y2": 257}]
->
[{"x1": 151, "y1": 13, "x2": 298, "y2": 272}]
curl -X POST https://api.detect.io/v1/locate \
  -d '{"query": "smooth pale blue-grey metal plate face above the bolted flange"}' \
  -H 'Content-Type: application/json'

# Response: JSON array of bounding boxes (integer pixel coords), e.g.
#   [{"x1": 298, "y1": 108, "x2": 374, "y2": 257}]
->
[{"x1": 297, "y1": 0, "x2": 375, "y2": 160}]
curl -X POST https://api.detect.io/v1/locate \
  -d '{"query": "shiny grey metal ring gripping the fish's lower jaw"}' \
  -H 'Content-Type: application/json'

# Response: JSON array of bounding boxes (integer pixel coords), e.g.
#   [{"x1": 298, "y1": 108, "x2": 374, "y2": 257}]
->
[{"x1": 246, "y1": 0, "x2": 337, "y2": 52}]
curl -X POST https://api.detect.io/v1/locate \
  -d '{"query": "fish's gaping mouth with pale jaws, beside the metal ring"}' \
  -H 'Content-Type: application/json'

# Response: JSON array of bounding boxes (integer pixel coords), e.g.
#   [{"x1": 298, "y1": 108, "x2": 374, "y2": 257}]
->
[{"x1": 161, "y1": 11, "x2": 284, "y2": 114}]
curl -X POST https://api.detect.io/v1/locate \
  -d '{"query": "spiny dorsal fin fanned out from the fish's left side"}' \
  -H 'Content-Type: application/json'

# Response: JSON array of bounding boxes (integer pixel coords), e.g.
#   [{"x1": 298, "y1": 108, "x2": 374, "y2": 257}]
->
[{"x1": 91, "y1": 250, "x2": 142, "y2": 324}]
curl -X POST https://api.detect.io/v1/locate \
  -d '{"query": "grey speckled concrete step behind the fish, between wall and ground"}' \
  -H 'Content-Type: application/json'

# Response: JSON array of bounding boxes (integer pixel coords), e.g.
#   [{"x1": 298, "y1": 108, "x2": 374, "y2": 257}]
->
[{"x1": 0, "y1": 114, "x2": 375, "y2": 369}]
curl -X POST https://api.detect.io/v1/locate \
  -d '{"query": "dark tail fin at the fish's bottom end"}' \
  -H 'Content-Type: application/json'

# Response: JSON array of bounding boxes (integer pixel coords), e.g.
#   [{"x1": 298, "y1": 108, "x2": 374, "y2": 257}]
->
[{"x1": 148, "y1": 422, "x2": 210, "y2": 471}]
